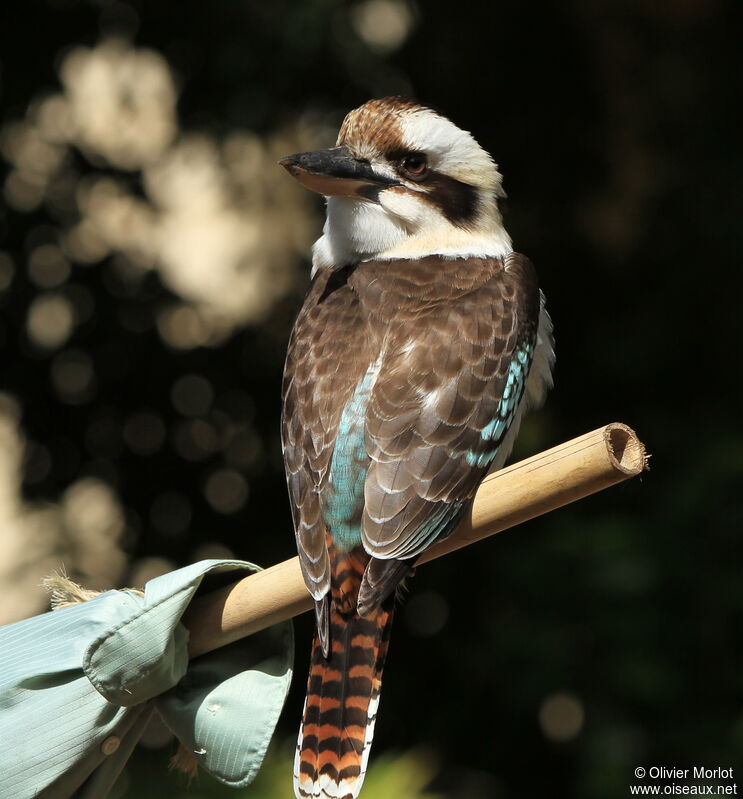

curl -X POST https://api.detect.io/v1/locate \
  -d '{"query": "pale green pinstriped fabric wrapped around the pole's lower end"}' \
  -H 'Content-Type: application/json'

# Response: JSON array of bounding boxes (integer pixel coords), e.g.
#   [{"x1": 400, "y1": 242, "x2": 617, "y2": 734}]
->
[{"x1": 0, "y1": 561, "x2": 293, "y2": 799}]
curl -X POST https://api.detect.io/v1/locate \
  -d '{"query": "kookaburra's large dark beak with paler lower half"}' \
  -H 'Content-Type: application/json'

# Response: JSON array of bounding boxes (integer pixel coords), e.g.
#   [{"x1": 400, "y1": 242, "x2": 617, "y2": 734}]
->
[{"x1": 279, "y1": 146, "x2": 398, "y2": 201}]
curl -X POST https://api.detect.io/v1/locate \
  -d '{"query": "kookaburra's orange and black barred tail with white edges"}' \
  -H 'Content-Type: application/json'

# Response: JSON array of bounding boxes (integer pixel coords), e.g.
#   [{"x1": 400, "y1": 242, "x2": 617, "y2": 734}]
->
[{"x1": 294, "y1": 597, "x2": 393, "y2": 799}]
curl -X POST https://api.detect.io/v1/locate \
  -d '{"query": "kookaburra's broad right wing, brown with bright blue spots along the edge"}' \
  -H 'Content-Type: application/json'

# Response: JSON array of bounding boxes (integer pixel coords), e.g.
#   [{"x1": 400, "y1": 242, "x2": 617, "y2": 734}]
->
[{"x1": 362, "y1": 254, "x2": 540, "y2": 564}]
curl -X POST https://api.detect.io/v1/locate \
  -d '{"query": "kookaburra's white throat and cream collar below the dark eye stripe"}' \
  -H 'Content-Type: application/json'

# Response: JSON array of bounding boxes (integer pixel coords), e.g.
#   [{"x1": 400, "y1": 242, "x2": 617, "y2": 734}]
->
[{"x1": 312, "y1": 192, "x2": 513, "y2": 274}]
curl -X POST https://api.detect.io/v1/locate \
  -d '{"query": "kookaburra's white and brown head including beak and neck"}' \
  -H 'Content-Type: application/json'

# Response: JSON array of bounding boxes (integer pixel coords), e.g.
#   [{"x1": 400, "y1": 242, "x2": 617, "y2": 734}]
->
[{"x1": 279, "y1": 97, "x2": 511, "y2": 267}]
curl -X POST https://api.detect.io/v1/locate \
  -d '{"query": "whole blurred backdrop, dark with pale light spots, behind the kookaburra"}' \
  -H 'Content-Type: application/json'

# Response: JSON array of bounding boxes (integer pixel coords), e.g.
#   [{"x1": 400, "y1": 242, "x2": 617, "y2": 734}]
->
[{"x1": 0, "y1": 0, "x2": 743, "y2": 799}]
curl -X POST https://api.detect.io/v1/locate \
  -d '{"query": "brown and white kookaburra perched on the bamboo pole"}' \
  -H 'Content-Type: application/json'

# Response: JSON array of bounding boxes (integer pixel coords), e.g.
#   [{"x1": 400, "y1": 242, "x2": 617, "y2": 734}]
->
[{"x1": 279, "y1": 97, "x2": 554, "y2": 799}]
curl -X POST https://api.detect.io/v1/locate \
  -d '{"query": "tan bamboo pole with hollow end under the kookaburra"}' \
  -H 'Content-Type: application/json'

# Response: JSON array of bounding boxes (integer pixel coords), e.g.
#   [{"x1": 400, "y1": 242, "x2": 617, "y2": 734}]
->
[{"x1": 183, "y1": 422, "x2": 648, "y2": 657}]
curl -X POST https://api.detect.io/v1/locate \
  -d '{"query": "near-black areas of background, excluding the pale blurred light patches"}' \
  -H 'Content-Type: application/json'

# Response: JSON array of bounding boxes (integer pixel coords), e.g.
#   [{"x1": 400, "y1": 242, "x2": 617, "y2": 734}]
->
[{"x1": 0, "y1": 0, "x2": 743, "y2": 799}]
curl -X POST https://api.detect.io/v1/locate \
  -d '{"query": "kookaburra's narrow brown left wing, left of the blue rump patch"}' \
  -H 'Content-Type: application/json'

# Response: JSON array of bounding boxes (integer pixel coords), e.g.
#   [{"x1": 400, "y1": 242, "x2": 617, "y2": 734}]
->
[{"x1": 281, "y1": 270, "x2": 367, "y2": 604}]
